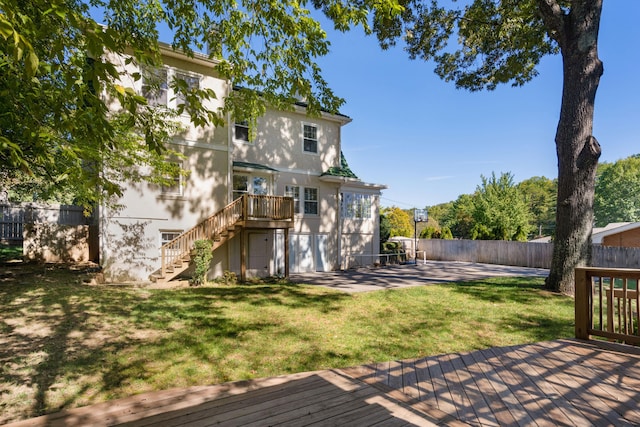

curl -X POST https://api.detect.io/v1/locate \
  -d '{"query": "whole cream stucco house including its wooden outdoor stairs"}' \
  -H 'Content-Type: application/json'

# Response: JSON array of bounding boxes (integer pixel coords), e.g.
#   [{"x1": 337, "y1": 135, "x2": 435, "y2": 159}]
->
[{"x1": 99, "y1": 47, "x2": 386, "y2": 281}]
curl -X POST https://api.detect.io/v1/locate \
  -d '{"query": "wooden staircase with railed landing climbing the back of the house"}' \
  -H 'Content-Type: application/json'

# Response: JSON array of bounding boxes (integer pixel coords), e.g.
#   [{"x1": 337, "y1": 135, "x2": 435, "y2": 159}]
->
[{"x1": 149, "y1": 194, "x2": 294, "y2": 282}]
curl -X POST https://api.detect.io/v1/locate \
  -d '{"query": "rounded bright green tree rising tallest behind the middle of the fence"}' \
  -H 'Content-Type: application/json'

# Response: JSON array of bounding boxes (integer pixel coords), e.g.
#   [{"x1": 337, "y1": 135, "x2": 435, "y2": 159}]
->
[{"x1": 472, "y1": 173, "x2": 530, "y2": 241}]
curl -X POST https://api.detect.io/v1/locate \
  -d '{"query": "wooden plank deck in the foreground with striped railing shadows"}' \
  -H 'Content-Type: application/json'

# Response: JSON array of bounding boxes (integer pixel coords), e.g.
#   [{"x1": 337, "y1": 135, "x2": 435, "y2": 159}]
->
[{"x1": 10, "y1": 340, "x2": 640, "y2": 427}]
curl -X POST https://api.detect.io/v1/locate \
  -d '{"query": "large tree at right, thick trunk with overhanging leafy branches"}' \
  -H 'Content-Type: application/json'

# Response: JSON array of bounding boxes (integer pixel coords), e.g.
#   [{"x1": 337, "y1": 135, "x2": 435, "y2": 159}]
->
[{"x1": 375, "y1": 0, "x2": 603, "y2": 294}]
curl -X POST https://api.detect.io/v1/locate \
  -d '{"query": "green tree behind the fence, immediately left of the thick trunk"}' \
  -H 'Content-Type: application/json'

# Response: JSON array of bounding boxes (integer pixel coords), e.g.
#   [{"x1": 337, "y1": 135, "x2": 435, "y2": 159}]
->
[{"x1": 518, "y1": 176, "x2": 558, "y2": 237}]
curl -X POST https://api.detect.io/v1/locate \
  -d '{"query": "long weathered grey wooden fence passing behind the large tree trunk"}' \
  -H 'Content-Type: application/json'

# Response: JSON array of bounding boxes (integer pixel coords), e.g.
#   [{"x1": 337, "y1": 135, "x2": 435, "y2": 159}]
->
[{"x1": 418, "y1": 239, "x2": 640, "y2": 268}]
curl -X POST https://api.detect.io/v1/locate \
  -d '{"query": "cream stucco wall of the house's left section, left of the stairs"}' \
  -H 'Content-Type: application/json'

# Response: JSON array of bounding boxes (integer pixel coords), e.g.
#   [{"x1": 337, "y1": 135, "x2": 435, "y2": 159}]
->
[{"x1": 100, "y1": 51, "x2": 230, "y2": 281}]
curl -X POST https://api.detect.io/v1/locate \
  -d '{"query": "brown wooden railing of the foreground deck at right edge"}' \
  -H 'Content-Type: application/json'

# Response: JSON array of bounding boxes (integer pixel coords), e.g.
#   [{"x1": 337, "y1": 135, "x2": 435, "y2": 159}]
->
[{"x1": 575, "y1": 267, "x2": 640, "y2": 345}]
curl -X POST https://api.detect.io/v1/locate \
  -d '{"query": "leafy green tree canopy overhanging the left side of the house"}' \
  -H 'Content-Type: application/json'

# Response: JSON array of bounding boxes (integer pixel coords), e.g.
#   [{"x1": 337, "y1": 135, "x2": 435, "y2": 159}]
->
[{"x1": 0, "y1": 0, "x2": 401, "y2": 211}]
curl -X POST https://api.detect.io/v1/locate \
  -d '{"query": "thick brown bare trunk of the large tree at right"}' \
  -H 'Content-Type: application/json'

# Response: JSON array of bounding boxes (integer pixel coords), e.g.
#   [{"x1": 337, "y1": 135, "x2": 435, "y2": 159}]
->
[{"x1": 545, "y1": 0, "x2": 603, "y2": 295}]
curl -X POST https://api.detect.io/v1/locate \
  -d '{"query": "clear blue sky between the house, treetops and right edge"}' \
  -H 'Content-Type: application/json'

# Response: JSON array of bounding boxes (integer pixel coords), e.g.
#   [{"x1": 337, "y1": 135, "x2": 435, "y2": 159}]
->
[{"x1": 320, "y1": 0, "x2": 640, "y2": 209}]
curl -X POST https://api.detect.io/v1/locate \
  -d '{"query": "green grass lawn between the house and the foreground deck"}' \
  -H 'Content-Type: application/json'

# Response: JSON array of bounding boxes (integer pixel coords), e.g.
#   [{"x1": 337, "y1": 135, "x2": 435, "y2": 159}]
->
[{"x1": 0, "y1": 265, "x2": 573, "y2": 424}]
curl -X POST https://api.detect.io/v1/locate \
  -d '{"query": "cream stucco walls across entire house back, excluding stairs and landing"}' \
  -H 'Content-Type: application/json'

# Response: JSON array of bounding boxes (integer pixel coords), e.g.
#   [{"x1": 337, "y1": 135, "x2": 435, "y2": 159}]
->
[{"x1": 100, "y1": 46, "x2": 382, "y2": 281}]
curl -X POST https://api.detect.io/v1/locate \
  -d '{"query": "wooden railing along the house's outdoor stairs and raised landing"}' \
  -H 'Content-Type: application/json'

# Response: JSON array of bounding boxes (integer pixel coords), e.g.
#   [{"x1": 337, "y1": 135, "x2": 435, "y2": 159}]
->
[{"x1": 160, "y1": 194, "x2": 293, "y2": 277}]
